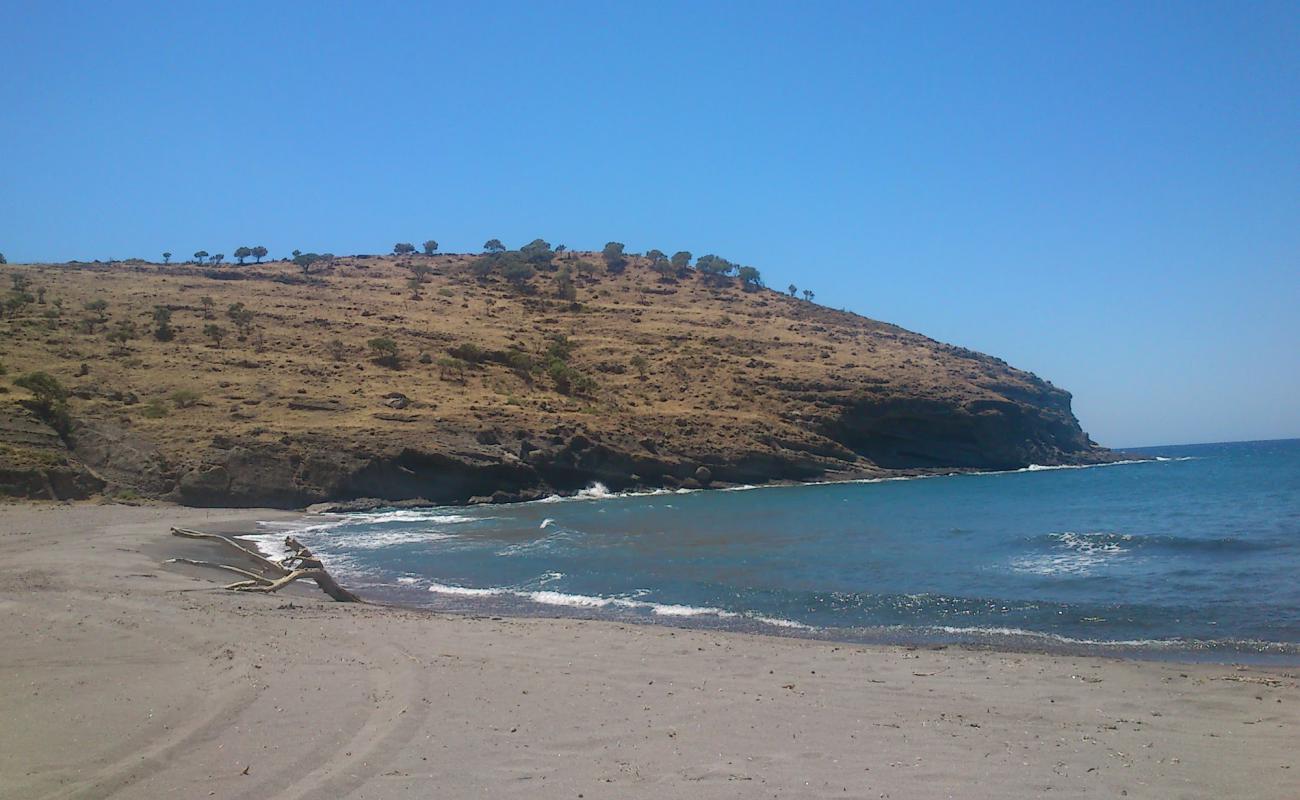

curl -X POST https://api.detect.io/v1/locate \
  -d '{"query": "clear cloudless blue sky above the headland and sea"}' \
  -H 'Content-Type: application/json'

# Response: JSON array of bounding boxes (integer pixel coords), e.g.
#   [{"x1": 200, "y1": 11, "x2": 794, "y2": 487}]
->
[{"x1": 0, "y1": 0, "x2": 1300, "y2": 446}]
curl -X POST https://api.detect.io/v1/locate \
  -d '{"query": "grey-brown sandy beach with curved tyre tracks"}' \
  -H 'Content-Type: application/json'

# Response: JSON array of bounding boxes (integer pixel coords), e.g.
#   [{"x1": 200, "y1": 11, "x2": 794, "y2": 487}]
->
[{"x1": 0, "y1": 503, "x2": 1300, "y2": 799}]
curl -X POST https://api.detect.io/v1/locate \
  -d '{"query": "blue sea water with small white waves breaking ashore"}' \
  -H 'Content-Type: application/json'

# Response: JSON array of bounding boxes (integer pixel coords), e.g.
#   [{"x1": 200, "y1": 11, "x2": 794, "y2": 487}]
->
[{"x1": 261, "y1": 440, "x2": 1300, "y2": 662}]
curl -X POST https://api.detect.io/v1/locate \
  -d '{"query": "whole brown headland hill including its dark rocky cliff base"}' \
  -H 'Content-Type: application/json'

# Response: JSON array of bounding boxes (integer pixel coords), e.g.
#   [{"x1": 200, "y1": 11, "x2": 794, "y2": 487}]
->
[{"x1": 0, "y1": 251, "x2": 1110, "y2": 507}]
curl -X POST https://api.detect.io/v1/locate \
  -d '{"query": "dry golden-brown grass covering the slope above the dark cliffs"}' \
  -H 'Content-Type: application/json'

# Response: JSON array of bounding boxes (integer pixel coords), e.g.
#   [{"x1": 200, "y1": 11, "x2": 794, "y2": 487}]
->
[{"x1": 0, "y1": 254, "x2": 1023, "y2": 473}]
